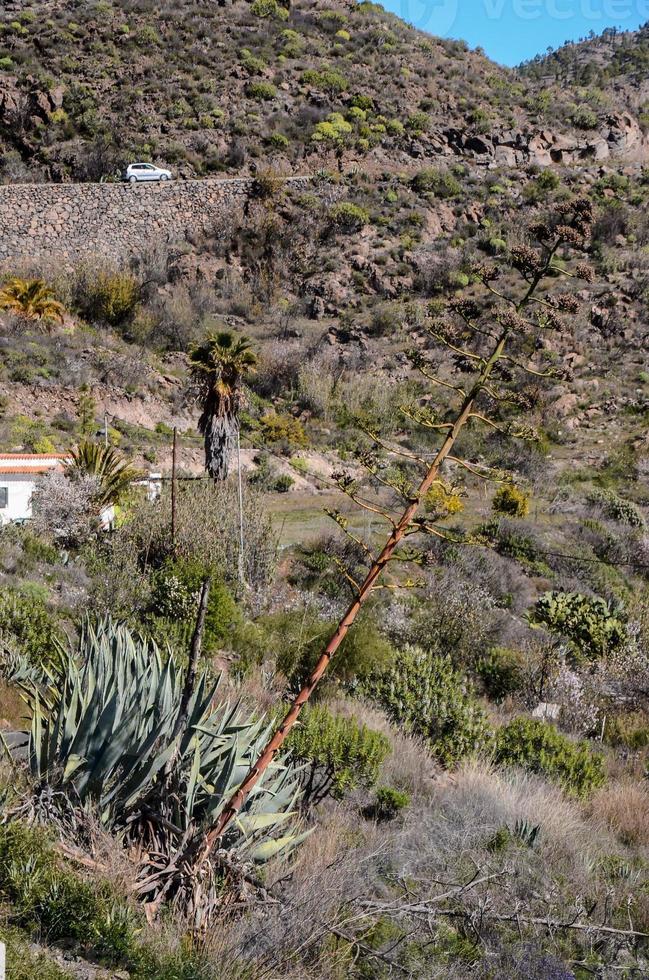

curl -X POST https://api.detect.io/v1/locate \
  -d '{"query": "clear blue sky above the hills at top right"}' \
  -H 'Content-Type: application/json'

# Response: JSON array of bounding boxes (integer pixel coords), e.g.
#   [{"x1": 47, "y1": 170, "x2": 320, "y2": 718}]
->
[{"x1": 382, "y1": 0, "x2": 649, "y2": 65}]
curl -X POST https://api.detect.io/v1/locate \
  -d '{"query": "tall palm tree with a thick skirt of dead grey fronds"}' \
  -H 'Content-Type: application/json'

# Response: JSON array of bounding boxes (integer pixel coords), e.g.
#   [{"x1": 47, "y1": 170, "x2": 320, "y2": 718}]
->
[{"x1": 189, "y1": 332, "x2": 257, "y2": 480}]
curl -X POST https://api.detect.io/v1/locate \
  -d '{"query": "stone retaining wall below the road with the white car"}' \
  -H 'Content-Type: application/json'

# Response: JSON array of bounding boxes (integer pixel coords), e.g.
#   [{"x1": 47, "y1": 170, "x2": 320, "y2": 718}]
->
[{"x1": 0, "y1": 177, "x2": 308, "y2": 267}]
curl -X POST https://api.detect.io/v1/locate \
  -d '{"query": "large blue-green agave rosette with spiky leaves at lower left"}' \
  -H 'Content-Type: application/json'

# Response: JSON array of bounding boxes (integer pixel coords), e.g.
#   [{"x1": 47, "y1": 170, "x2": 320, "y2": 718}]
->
[{"x1": 19, "y1": 618, "x2": 304, "y2": 912}]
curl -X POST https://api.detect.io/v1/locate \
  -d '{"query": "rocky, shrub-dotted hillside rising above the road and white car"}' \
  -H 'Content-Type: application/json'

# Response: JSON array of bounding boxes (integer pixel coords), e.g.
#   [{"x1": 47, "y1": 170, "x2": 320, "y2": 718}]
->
[{"x1": 0, "y1": 0, "x2": 639, "y2": 180}]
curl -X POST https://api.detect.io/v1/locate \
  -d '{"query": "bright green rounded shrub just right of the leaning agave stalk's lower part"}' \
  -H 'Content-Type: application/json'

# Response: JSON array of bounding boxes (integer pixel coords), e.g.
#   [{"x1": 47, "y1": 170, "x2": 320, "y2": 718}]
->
[{"x1": 286, "y1": 704, "x2": 391, "y2": 804}]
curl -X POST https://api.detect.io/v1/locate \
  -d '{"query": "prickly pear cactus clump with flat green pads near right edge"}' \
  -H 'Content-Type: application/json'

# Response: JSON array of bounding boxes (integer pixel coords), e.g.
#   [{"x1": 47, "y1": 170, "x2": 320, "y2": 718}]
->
[{"x1": 530, "y1": 592, "x2": 626, "y2": 660}]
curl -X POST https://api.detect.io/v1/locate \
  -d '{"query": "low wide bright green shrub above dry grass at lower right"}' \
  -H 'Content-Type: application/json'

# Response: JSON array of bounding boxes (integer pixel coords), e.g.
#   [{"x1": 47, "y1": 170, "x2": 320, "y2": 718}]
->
[{"x1": 495, "y1": 718, "x2": 606, "y2": 796}]
